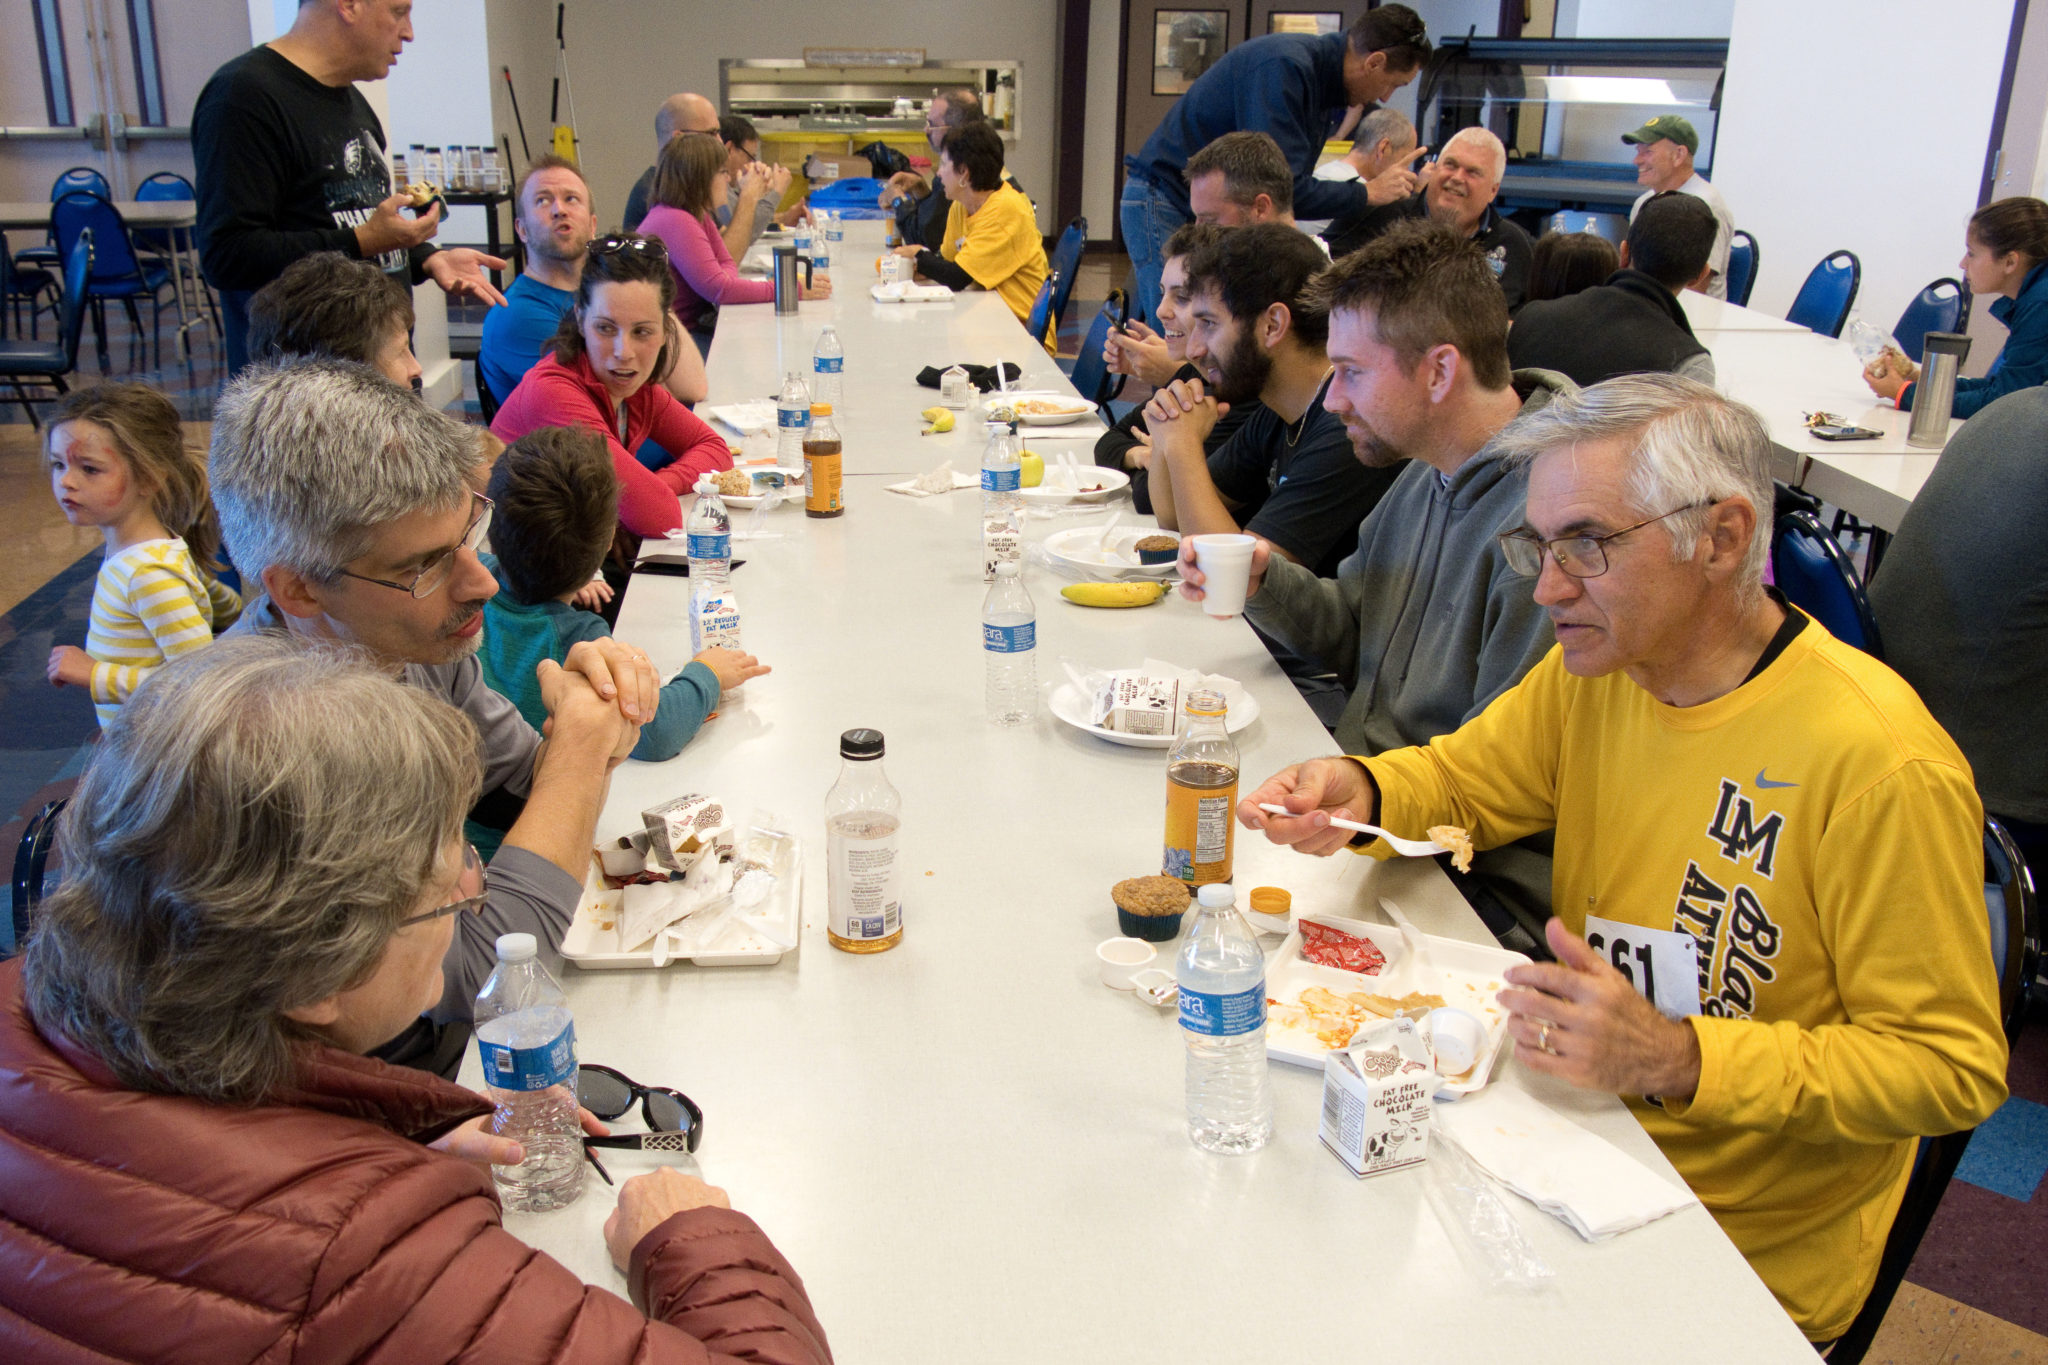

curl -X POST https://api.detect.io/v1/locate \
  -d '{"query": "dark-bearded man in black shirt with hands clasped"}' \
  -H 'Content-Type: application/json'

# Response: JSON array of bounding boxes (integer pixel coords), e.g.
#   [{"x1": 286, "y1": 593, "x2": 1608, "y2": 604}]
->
[{"x1": 1145, "y1": 223, "x2": 1395, "y2": 575}]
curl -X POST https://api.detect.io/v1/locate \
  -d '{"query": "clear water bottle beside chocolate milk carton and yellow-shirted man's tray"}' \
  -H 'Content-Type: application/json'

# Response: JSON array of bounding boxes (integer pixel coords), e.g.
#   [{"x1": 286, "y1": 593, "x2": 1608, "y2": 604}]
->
[{"x1": 1176, "y1": 882, "x2": 1274, "y2": 1156}]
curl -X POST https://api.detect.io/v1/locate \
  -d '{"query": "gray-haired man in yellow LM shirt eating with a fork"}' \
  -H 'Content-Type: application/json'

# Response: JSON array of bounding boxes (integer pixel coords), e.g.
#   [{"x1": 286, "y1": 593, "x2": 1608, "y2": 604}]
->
[{"x1": 1220, "y1": 375, "x2": 2007, "y2": 1342}]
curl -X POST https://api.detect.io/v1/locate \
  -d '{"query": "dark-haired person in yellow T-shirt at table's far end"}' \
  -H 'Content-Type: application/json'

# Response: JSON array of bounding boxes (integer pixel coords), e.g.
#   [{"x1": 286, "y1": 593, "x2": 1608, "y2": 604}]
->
[{"x1": 897, "y1": 121, "x2": 1053, "y2": 350}]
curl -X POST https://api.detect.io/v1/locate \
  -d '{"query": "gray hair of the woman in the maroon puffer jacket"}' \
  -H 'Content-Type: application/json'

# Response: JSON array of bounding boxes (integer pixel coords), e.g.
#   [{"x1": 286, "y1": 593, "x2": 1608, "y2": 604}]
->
[{"x1": 23, "y1": 634, "x2": 481, "y2": 1103}]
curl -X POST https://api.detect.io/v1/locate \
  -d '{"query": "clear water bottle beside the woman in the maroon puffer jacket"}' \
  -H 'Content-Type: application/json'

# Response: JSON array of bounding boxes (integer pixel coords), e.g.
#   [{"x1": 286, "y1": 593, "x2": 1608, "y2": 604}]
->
[{"x1": 477, "y1": 933, "x2": 584, "y2": 1212}]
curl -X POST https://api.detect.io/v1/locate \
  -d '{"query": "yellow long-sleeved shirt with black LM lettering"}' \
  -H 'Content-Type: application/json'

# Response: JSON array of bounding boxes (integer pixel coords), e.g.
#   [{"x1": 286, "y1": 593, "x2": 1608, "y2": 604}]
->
[{"x1": 1360, "y1": 622, "x2": 2007, "y2": 1340}]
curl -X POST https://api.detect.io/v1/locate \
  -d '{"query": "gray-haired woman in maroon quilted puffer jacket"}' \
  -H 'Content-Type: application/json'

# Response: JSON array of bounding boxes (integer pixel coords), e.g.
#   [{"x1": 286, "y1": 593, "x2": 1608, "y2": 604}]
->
[{"x1": 0, "y1": 636, "x2": 831, "y2": 1365}]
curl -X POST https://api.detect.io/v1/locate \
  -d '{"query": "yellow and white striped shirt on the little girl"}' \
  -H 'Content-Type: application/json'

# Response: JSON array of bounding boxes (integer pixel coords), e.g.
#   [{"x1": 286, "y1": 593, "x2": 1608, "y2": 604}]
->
[{"x1": 86, "y1": 540, "x2": 242, "y2": 724}]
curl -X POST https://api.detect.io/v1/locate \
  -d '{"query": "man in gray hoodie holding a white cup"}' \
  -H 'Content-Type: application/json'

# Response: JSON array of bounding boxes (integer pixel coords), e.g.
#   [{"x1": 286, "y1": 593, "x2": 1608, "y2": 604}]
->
[{"x1": 1179, "y1": 223, "x2": 1573, "y2": 943}]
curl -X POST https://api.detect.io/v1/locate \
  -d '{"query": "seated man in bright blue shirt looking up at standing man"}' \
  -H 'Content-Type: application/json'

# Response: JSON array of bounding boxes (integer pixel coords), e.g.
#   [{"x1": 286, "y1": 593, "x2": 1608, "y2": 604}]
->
[{"x1": 477, "y1": 151, "x2": 711, "y2": 403}]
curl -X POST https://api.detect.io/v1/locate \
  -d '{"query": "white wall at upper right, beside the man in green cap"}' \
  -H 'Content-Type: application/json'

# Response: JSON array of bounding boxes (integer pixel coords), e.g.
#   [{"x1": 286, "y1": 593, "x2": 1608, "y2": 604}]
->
[{"x1": 1712, "y1": 0, "x2": 2013, "y2": 327}]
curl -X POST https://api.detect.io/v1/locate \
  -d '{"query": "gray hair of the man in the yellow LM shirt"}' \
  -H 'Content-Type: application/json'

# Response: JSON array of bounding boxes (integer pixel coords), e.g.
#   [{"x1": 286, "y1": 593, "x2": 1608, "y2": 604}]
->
[{"x1": 1497, "y1": 375, "x2": 1776, "y2": 604}]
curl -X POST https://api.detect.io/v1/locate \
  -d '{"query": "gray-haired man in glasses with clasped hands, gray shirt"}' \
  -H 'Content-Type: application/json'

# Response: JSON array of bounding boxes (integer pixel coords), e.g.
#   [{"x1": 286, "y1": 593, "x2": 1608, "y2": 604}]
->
[{"x1": 209, "y1": 360, "x2": 659, "y2": 1060}]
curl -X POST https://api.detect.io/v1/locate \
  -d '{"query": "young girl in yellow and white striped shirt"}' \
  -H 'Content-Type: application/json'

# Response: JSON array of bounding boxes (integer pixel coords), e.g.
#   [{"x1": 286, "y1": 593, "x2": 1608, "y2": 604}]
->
[{"x1": 45, "y1": 385, "x2": 242, "y2": 724}]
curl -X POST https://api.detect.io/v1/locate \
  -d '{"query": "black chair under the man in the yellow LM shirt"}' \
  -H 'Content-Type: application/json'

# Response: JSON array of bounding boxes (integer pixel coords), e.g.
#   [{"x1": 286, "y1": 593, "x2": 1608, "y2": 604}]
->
[{"x1": 1827, "y1": 819, "x2": 2042, "y2": 1365}]
